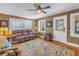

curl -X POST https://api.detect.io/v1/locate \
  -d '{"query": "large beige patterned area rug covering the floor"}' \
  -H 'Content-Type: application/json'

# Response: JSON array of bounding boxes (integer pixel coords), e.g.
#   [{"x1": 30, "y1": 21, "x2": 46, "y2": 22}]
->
[{"x1": 14, "y1": 39, "x2": 74, "y2": 56}]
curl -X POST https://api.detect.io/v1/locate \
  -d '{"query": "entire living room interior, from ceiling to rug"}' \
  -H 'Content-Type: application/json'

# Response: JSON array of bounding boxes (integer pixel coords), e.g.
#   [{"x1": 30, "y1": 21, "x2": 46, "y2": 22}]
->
[{"x1": 0, "y1": 3, "x2": 79, "y2": 56}]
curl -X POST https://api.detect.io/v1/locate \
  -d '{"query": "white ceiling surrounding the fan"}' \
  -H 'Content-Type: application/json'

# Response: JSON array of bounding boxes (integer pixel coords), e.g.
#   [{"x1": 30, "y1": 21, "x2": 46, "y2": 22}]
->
[{"x1": 0, "y1": 3, "x2": 79, "y2": 19}]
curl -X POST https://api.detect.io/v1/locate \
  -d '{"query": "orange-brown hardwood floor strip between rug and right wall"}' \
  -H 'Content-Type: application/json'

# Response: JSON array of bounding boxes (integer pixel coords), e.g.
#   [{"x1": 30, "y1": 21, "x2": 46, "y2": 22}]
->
[{"x1": 46, "y1": 40, "x2": 79, "y2": 56}]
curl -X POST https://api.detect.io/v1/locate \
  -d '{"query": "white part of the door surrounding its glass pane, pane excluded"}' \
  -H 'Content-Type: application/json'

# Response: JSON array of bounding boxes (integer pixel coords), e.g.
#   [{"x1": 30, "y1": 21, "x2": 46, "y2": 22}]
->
[{"x1": 53, "y1": 16, "x2": 67, "y2": 43}]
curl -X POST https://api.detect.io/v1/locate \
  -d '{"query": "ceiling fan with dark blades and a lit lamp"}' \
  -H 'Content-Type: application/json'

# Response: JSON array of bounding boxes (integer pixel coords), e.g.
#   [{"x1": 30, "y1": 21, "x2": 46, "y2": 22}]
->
[{"x1": 28, "y1": 4, "x2": 50, "y2": 13}]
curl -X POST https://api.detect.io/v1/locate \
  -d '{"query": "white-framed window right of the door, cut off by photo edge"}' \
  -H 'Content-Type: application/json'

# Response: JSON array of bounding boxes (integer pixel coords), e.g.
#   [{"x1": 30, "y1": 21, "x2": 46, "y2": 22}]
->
[{"x1": 70, "y1": 13, "x2": 79, "y2": 37}]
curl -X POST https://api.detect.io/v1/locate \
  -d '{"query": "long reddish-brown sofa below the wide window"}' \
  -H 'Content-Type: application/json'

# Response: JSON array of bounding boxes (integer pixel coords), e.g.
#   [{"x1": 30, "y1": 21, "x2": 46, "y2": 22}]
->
[{"x1": 12, "y1": 29, "x2": 37, "y2": 43}]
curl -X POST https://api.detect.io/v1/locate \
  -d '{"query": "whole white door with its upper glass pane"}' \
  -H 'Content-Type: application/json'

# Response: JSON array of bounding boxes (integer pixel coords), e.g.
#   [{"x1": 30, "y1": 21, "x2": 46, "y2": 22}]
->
[{"x1": 53, "y1": 15, "x2": 67, "y2": 43}]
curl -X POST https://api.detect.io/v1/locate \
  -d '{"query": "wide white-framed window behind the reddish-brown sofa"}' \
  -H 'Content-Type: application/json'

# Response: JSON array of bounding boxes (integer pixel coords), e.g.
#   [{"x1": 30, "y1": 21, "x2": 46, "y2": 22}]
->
[{"x1": 10, "y1": 18, "x2": 32, "y2": 30}]
